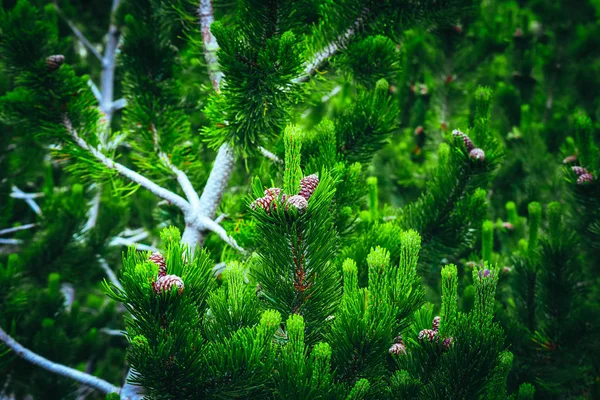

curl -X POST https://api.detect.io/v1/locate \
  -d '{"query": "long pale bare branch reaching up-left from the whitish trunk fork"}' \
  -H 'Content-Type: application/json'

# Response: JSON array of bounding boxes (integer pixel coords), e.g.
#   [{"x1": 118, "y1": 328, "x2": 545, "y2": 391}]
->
[{"x1": 63, "y1": 118, "x2": 190, "y2": 214}]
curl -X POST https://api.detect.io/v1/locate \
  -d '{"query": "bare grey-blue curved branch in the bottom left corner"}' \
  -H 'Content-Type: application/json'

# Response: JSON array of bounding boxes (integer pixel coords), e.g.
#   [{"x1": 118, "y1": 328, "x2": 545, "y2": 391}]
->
[{"x1": 0, "y1": 328, "x2": 121, "y2": 394}]
